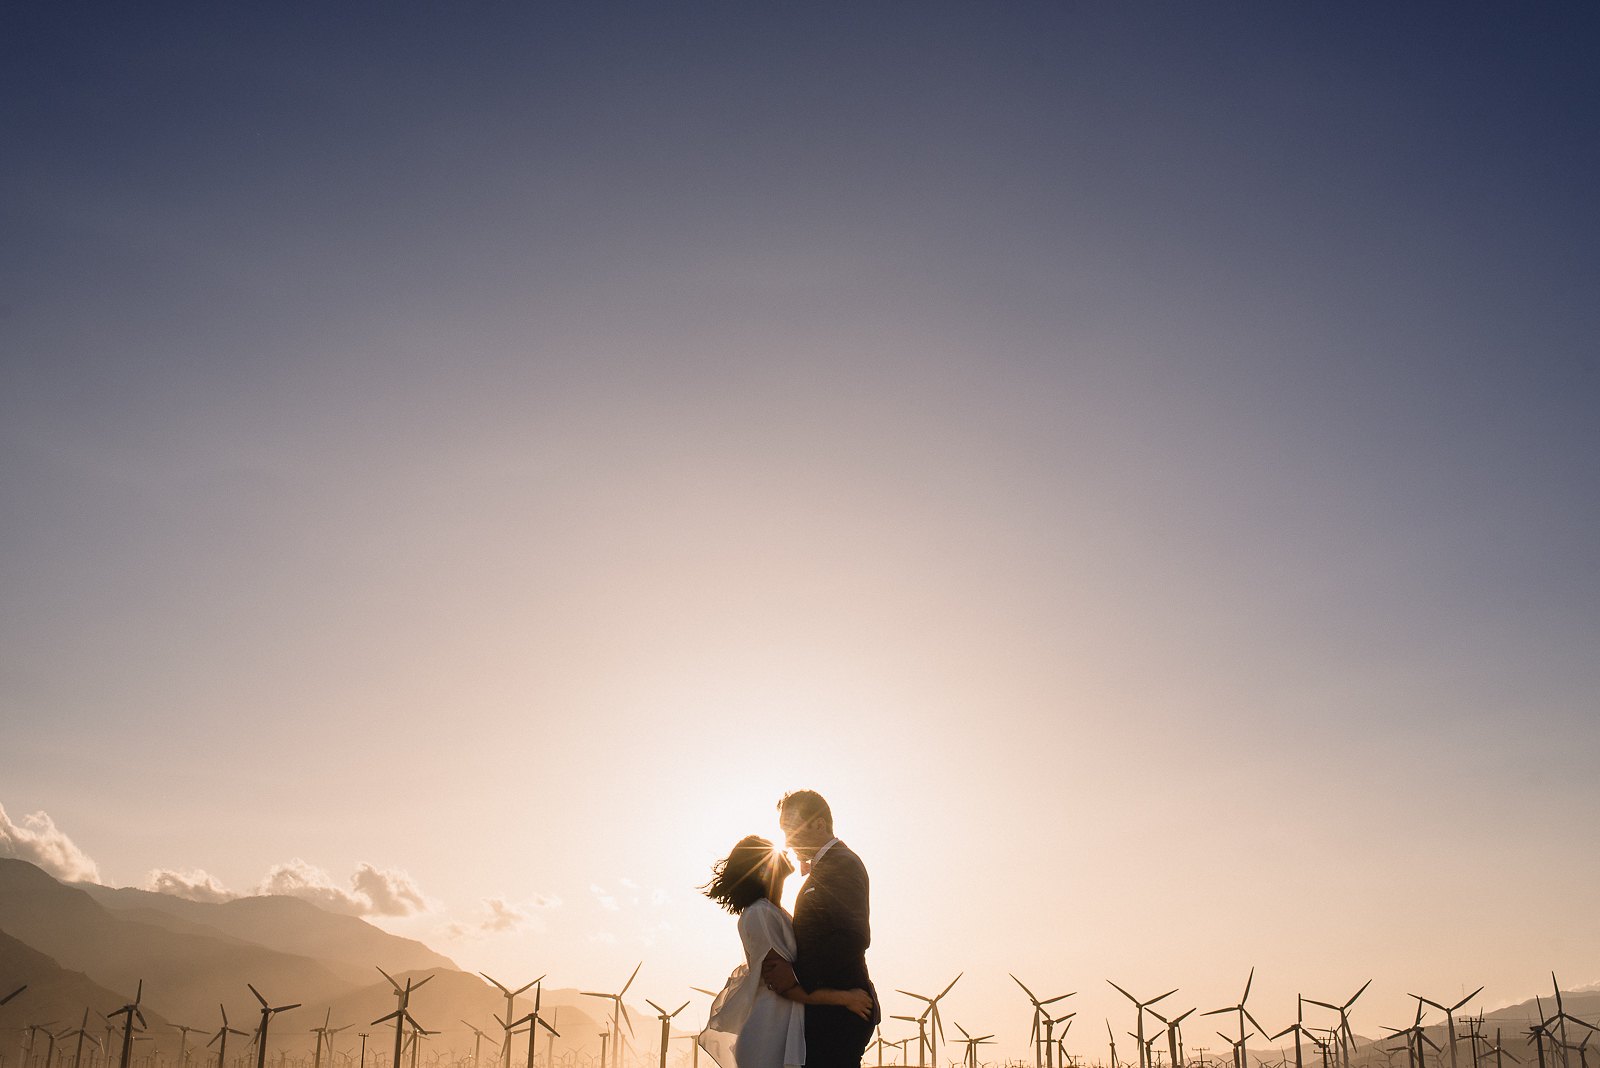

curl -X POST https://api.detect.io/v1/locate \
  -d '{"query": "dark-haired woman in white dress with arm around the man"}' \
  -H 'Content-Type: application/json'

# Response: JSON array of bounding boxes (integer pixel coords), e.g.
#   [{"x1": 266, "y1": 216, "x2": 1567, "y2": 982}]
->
[{"x1": 699, "y1": 835, "x2": 872, "y2": 1068}]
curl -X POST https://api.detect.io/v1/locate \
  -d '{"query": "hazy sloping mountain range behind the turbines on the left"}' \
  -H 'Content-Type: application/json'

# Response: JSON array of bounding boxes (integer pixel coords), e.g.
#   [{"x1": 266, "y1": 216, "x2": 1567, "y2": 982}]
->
[{"x1": 0, "y1": 859, "x2": 624, "y2": 1063}]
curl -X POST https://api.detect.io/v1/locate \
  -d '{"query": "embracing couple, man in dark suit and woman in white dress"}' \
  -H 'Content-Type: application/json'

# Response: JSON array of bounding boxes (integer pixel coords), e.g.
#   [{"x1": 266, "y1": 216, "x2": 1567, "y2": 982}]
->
[{"x1": 699, "y1": 790, "x2": 883, "y2": 1068}]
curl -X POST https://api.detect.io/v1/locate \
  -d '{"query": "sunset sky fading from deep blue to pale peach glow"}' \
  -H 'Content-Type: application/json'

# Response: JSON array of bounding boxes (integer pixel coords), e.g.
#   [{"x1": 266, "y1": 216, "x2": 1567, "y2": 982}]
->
[{"x1": 0, "y1": 3, "x2": 1600, "y2": 1057}]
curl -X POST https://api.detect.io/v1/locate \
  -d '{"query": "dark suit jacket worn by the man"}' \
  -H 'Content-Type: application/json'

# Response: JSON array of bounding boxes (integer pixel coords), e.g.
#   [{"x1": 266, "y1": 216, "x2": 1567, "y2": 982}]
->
[{"x1": 795, "y1": 841, "x2": 883, "y2": 1026}]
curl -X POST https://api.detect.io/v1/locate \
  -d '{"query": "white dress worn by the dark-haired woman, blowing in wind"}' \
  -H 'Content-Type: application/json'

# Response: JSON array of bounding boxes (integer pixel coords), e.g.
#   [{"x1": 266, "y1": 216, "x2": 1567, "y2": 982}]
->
[{"x1": 699, "y1": 899, "x2": 805, "y2": 1068}]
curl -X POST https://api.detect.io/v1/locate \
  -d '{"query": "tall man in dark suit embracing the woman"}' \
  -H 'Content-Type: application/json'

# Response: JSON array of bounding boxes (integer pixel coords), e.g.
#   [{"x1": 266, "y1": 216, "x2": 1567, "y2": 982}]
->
[{"x1": 762, "y1": 790, "x2": 883, "y2": 1068}]
